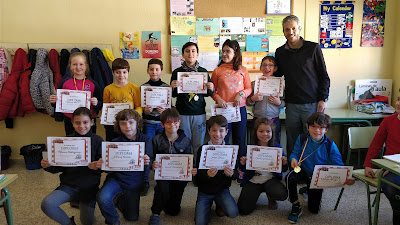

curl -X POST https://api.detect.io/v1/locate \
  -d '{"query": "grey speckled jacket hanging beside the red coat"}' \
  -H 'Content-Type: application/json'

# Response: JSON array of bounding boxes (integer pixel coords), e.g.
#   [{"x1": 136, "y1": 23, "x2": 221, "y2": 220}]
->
[{"x1": 29, "y1": 48, "x2": 55, "y2": 115}]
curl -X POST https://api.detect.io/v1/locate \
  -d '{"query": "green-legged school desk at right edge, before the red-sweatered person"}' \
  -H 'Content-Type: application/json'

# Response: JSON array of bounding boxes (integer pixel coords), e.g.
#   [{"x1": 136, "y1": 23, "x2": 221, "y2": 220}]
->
[{"x1": 371, "y1": 159, "x2": 400, "y2": 225}]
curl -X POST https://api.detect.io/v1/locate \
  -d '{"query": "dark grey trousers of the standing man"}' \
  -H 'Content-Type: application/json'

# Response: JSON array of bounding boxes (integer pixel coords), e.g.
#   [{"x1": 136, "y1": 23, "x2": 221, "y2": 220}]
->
[{"x1": 285, "y1": 102, "x2": 318, "y2": 157}]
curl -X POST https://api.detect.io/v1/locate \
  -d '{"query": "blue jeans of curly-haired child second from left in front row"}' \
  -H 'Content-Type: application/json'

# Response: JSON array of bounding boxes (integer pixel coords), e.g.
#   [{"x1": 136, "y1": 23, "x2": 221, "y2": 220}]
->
[{"x1": 97, "y1": 178, "x2": 140, "y2": 224}]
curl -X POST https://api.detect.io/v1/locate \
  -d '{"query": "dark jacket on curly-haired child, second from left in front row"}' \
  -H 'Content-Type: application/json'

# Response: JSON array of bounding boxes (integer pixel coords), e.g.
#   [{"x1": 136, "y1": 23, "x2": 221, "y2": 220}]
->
[{"x1": 107, "y1": 133, "x2": 153, "y2": 190}]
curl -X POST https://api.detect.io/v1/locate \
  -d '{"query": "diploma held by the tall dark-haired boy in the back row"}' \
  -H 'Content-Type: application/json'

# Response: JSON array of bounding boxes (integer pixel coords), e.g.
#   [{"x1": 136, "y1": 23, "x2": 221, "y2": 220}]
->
[{"x1": 178, "y1": 72, "x2": 208, "y2": 94}]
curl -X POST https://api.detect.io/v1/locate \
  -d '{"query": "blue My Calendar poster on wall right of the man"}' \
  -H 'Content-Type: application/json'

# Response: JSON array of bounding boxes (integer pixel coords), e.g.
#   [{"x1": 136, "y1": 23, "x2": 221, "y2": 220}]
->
[{"x1": 319, "y1": 3, "x2": 354, "y2": 48}]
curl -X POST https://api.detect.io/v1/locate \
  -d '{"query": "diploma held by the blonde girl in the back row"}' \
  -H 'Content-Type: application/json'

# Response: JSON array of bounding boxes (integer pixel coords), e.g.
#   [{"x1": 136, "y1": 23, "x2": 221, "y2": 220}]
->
[{"x1": 56, "y1": 89, "x2": 91, "y2": 113}]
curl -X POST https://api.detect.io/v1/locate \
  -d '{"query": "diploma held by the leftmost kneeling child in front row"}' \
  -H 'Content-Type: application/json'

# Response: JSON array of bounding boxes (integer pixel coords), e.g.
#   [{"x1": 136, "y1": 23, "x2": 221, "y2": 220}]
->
[{"x1": 47, "y1": 137, "x2": 92, "y2": 167}]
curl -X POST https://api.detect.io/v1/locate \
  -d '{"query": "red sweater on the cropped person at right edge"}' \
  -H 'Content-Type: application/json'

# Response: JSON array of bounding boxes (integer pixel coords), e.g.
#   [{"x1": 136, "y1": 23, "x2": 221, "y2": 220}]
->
[{"x1": 364, "y1": 113, "x2": 400, "y2": 167}]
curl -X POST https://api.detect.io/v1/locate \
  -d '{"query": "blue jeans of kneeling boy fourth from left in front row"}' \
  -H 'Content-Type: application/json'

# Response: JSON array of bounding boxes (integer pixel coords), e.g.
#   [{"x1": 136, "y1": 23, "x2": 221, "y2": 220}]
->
[{"x1": 194, "y1": 189, "x2": 239, "y2": 225}]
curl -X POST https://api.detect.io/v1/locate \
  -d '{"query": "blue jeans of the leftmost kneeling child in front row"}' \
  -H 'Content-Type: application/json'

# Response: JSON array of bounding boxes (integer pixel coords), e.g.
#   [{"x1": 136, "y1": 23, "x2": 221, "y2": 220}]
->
[{"x1": 41, "y1": 186, "x2": 96, "y2": 225}]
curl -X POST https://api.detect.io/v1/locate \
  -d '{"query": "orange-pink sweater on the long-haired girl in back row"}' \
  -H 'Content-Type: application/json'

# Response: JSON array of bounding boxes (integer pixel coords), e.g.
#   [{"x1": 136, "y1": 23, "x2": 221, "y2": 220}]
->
[{"x1": 211, "y1": 64, "x2": 253, "y2": 107}]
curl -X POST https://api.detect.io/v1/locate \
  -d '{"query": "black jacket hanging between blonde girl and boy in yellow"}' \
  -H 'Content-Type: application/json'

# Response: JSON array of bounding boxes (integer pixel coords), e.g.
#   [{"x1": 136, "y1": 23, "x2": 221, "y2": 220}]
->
[{"x1": 90, "y1": 48, "x2": 113, "y2": 90}]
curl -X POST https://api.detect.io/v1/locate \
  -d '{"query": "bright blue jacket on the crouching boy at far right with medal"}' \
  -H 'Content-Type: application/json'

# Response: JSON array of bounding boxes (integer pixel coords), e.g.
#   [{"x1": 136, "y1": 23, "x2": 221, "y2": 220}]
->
[{"x1": 288, "y1": 134, "x2": 343, "y2": 177}]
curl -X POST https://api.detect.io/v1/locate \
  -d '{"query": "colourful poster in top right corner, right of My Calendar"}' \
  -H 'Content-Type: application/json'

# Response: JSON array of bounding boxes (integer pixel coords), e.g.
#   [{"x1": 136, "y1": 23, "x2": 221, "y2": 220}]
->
[{"x1": 361, "y1": 0, "x2": 386, "y2": 47}]
